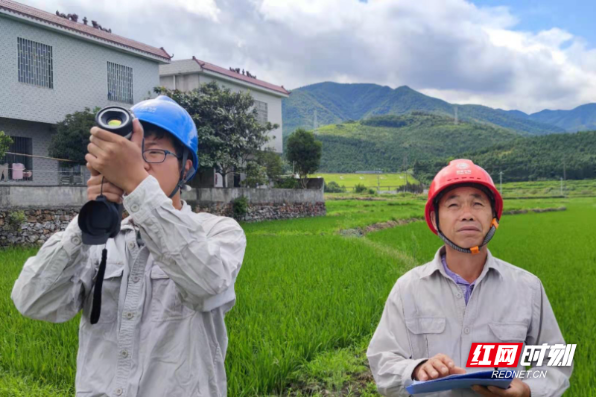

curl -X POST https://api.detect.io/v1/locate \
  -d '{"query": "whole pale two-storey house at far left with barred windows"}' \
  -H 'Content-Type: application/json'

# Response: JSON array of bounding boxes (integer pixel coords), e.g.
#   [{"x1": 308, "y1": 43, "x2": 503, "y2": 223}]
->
[{"x1": 0, "y1": 0, "x2": 170, "y2": 185}]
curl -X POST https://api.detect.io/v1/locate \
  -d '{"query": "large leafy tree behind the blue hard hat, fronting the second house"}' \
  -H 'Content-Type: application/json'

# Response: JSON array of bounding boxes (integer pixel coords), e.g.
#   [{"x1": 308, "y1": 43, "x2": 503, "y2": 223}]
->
[{"x1": 154, "y1": 82, "x2": 279, "y2": 187}]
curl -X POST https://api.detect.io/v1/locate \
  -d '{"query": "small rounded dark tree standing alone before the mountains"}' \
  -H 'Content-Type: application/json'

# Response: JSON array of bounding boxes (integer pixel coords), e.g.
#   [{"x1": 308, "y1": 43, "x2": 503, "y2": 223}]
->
[{"x1": 286, "y1": 128, "x2": 323, "y2": 189}]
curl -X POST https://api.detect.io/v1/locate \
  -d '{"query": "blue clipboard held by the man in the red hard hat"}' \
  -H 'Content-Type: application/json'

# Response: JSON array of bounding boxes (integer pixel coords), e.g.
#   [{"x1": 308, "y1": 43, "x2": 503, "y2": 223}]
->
[{"x1": 406, "y1": 370, "x2": 514, "y2": 394}]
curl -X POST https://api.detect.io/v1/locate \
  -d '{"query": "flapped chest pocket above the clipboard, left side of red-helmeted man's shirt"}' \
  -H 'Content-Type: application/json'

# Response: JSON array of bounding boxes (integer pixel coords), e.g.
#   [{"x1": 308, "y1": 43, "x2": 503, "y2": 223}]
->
[{"x1": 406, "y1": 317, "x2": 445, "y2": 359}]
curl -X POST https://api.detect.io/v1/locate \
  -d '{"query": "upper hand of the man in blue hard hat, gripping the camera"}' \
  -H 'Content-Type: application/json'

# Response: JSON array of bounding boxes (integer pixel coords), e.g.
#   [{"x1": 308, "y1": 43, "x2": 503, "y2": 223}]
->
[{"x1": 85, "y1": 119, "x2": 149, "y2": 194}]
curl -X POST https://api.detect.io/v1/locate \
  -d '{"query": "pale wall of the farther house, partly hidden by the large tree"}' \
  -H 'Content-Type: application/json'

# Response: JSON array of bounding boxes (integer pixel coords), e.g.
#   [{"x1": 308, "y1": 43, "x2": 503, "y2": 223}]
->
[{"x1": 160, "y1": 71, "x2": 283, "y2": 153}]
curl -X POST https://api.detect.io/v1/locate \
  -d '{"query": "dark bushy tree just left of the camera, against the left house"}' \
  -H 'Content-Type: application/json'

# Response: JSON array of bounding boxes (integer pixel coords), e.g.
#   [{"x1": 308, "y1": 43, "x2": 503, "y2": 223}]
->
[{"x1": 48, "y1": 107, "x2": 100, "y2": 165}]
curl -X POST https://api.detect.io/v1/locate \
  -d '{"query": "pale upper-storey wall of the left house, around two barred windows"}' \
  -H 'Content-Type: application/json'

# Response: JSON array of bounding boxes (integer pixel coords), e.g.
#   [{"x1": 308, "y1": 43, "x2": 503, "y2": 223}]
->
[{"x1": 0, "y1": 16, "x2": 159, "y2": 124}]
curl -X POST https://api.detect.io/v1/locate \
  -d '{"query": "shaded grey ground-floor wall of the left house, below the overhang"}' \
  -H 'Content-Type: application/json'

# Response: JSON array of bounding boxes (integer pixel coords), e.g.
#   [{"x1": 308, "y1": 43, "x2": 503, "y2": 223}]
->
[{"x1": 0, "y1": 117, "x2": 59, "y2": 185}]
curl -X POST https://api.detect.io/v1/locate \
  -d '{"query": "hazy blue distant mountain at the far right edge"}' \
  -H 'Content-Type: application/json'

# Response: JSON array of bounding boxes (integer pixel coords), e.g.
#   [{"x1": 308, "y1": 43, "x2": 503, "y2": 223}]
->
[{"x1": 520, "y1": 103, "x2": 596, "y2": 132}]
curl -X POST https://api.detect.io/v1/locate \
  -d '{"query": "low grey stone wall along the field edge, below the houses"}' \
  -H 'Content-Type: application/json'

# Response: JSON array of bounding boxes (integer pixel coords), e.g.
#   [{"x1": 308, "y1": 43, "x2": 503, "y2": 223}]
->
[{"x1": 0, "y1": 186, "x2": 326, "y2": 247}]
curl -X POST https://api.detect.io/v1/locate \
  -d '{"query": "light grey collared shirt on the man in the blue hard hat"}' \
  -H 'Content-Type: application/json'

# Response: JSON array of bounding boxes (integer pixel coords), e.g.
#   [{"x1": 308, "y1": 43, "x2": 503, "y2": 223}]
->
[{"x1": 12, "y1": 176, "x2": 246, "y2": 397}]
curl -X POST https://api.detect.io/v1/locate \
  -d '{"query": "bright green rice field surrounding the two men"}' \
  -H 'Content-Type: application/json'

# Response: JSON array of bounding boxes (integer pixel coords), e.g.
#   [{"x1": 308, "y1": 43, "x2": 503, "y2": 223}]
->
[{"x1": 0, "y1": 195, "x2": 596, "y2": 397}]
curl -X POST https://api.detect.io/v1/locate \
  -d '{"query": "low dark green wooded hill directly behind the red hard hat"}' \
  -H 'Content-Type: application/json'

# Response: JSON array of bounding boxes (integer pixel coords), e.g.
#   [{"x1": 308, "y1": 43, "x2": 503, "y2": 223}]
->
[{"x1": 414, "y1": 131, "x2": 596, "y2": 182}]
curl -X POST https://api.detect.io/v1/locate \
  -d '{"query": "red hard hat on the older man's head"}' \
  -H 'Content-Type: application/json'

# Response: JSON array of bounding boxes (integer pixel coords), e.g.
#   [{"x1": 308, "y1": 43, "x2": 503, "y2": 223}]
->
[{"x1": 424, "y1": 159, "x2": 503, "y2": 234}]
